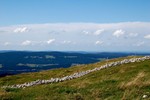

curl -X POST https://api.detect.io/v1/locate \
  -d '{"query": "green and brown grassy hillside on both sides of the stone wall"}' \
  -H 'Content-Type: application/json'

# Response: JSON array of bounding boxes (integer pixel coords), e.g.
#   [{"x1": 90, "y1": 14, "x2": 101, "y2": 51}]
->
[{"x1": 0, "y1": 57, "x2": 150, "y2": 100}]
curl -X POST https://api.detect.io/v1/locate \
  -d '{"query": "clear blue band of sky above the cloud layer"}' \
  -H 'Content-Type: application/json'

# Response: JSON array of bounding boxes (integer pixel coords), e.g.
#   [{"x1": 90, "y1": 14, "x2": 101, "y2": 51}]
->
[{"x1": 0, "y1": 0, "x2": 150, "y2": 26}]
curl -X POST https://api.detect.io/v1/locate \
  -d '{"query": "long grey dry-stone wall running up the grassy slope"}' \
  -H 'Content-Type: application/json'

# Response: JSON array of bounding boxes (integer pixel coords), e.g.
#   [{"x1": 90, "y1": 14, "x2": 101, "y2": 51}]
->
[{"x1": 3, "y1": 56, "x2": 150, "y2": 88}]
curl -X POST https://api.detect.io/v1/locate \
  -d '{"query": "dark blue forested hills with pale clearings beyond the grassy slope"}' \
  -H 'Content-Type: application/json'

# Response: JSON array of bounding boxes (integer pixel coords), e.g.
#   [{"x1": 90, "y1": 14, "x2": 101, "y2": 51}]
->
[{"x1": 0, "y1": 51, "x2": 148, "y2": 76}]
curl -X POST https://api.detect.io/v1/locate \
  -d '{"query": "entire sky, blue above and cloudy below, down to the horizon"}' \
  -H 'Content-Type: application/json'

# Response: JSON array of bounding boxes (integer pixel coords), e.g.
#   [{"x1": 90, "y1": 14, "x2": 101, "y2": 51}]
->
[{"x1": 0, "y1": 0, "x2": 150, "y2": 52}]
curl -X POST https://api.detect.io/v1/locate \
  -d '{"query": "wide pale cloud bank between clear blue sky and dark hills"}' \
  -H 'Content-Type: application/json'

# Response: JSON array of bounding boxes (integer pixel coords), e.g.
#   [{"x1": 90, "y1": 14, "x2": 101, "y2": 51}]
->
[{"x1": 0, "y1": 22, "x2": 150, "y2": 51}]
